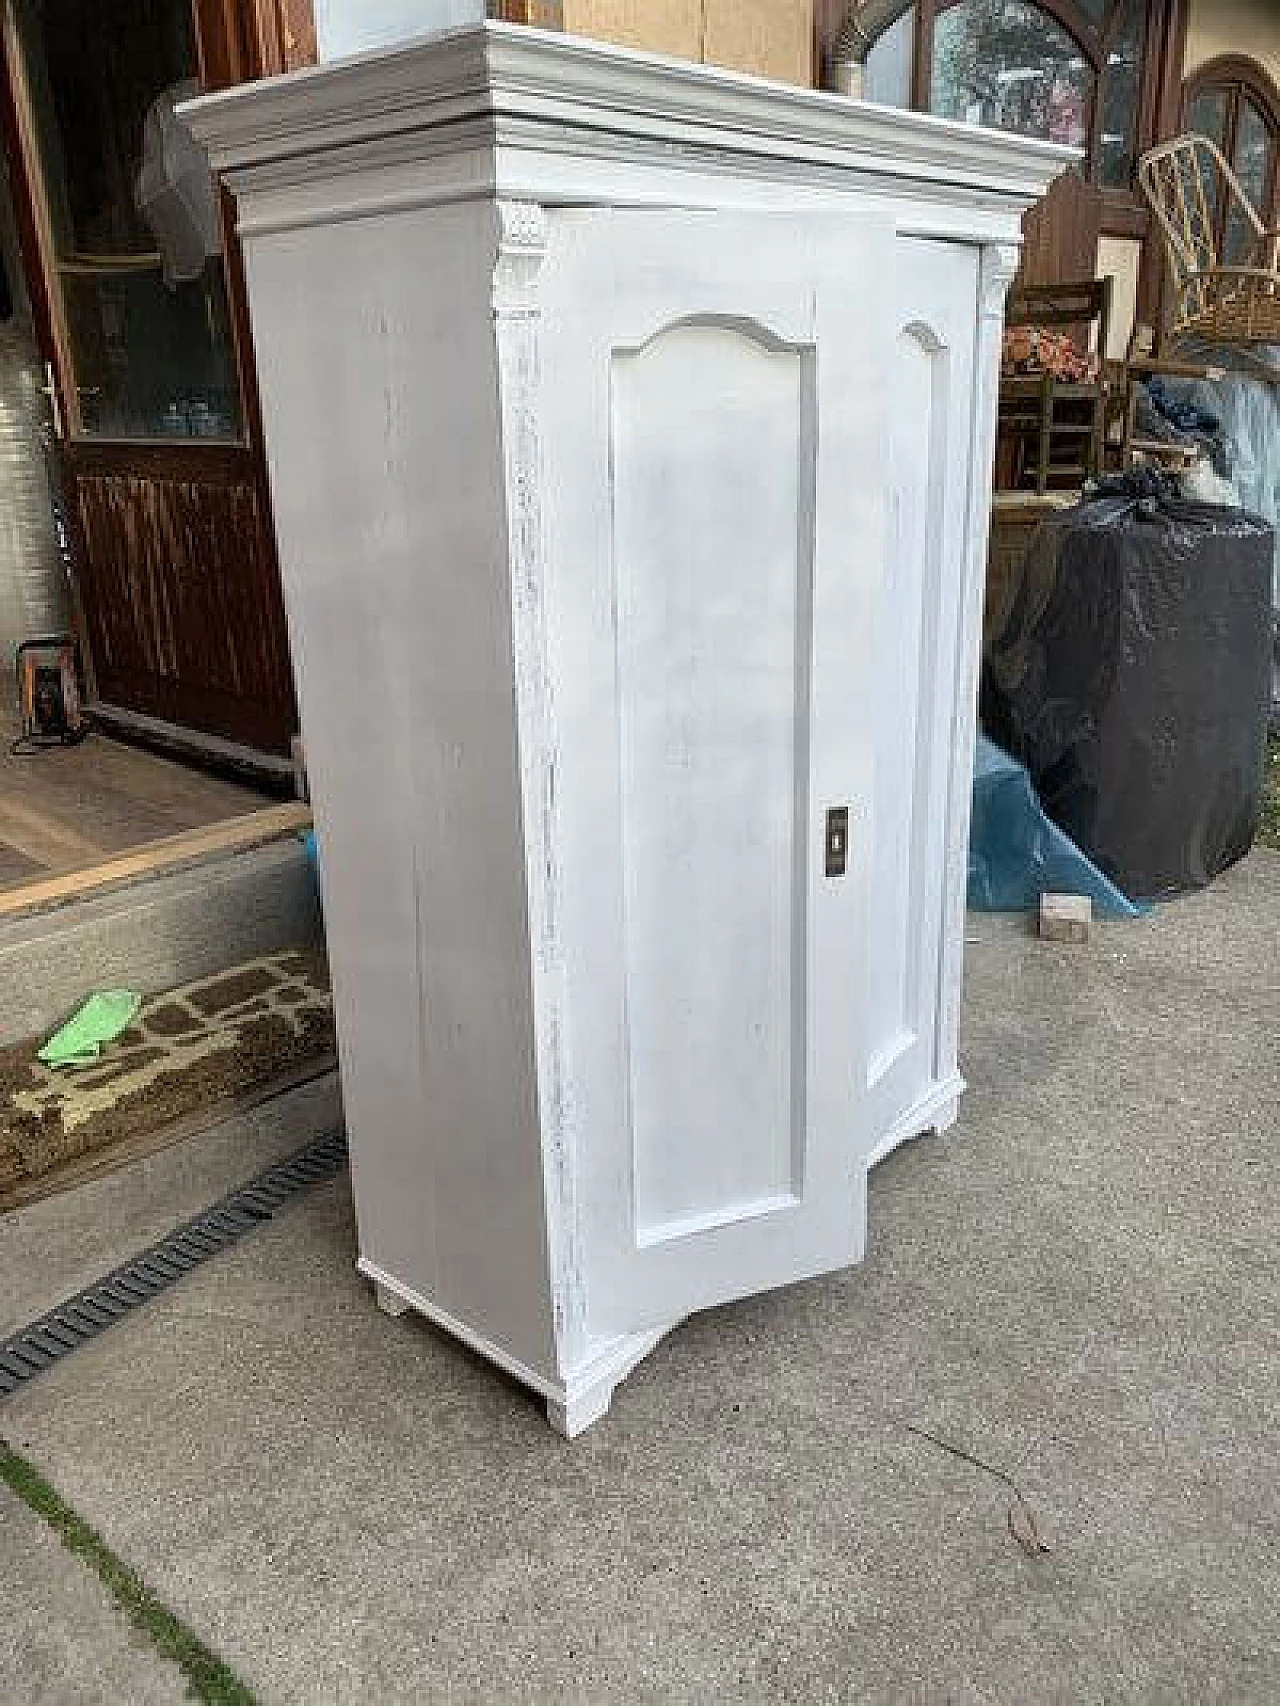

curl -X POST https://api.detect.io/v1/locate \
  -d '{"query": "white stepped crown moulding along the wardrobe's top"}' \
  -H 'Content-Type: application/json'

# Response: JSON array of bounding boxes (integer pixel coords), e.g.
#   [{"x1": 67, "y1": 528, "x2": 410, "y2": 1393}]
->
[{"x1": 181, "y1": 22, "x2": 1079, "y2": 215}]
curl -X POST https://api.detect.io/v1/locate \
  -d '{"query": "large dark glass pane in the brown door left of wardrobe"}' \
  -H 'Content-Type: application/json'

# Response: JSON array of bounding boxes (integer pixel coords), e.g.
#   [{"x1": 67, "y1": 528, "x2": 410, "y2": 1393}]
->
[{"x1": 15, "y1": 0, "x2": 241, "y2": 440}]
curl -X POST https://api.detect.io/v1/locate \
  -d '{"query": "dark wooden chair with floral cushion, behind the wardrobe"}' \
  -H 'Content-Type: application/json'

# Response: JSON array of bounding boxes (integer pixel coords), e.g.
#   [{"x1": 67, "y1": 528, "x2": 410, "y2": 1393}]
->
[{"x1": 997, "y1": 278, "x2": 1111, "y2": 495}]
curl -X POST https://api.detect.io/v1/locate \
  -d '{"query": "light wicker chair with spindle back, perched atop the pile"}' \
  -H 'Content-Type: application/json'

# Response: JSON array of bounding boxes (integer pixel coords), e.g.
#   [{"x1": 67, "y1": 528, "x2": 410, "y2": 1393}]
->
[{"x1": 1138, "y1": 135, "x2": 1280, "y2": 356}]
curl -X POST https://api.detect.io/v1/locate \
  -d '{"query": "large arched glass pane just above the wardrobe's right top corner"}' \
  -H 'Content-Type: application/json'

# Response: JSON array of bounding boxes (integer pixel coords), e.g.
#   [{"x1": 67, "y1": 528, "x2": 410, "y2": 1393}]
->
[{"x1": 930, "y1": 0, "x2": 1094, "y2": 147}]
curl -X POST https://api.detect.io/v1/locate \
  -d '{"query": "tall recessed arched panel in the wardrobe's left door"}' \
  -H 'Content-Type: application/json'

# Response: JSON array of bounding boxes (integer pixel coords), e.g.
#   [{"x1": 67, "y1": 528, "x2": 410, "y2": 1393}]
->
[{"x1": 617, "y1": 322, "x2": 816, "y2": 1247}]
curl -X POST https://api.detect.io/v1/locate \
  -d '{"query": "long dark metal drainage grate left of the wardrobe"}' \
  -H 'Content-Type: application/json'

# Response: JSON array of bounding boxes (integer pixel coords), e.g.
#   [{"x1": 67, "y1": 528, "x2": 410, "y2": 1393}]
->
[{"x1": 0, "y1": 1131, "x2": 346, "y2": 1399}]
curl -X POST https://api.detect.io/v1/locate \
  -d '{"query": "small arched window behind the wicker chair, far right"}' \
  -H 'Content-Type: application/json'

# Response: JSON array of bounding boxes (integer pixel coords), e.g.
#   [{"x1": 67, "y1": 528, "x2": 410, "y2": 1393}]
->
[{"x1": 1183, "y1": 55, "x2": 1280, "y2": 263}]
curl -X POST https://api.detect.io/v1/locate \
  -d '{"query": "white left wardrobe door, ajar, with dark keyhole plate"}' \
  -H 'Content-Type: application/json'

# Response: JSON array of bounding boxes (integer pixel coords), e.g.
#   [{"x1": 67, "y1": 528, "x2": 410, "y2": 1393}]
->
[{"x1": 541, "y1": 210, "x2": 894, "y2": 1336}]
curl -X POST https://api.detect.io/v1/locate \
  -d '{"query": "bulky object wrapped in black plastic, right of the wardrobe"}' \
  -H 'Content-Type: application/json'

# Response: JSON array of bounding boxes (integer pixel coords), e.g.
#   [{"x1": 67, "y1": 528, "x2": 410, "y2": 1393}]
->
[{"x1": 983, "y1": 469, "x2": 1275, "y2": 899}]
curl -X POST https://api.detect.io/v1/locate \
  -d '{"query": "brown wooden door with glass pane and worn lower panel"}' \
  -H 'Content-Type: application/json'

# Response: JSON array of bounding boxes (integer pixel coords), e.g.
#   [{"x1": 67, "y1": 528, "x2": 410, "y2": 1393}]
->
[{"x1": 3, "y1": 0, "x2": 297, "y2": 756}]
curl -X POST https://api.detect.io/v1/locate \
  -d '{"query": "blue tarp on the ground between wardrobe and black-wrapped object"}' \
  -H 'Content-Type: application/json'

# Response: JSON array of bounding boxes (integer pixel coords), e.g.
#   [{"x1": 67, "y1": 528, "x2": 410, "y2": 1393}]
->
[{"x1": 969, "y1": 735, "x2": 1145, "y2": 918}]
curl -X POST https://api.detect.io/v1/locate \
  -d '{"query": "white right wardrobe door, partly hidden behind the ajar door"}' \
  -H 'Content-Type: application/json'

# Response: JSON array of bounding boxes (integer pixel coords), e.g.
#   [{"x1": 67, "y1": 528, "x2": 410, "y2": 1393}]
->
[{"x1": 867, "y1": 239, "x2": 978, "y2": 1141}]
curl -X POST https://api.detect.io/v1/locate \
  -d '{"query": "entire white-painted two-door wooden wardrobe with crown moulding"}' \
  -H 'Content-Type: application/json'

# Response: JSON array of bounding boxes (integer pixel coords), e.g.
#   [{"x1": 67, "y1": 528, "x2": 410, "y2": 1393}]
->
[{"x1": 188, "y1": 26, "x2": 1065, "y2": 1435}]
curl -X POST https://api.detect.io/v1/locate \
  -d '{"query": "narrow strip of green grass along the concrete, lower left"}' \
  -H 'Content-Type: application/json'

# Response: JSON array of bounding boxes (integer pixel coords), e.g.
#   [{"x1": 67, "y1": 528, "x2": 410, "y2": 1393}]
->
[{"x1": 0, "y1": 1440, "x2": 254, "y2": 1706}]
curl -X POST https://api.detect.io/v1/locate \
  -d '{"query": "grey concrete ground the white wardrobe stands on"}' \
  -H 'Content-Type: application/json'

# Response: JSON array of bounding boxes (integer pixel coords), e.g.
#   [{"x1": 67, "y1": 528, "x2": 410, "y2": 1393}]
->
[{"x1": 0, "y1": 853, "x2": 1280, "y2": 1706}]
